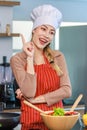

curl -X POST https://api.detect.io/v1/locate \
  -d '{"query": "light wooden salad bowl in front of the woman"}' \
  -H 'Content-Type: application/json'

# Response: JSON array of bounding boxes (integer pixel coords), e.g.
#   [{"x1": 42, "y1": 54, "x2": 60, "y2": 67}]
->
[{"x1": 40, "y1": 112, "x2": 80, "y2": 130}]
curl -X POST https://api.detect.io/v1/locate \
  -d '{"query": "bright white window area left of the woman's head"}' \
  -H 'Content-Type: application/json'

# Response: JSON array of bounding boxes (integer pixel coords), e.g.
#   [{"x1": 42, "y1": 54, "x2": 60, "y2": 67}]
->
[{"x1": 12, "y1": 21, "x2": 33, "y2": 55}]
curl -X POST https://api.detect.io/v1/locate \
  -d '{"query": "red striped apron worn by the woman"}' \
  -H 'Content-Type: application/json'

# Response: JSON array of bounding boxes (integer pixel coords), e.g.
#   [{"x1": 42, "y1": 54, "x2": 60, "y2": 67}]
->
[{"x1": 21, "y1": 58, "x2": 63, "y2": 130}]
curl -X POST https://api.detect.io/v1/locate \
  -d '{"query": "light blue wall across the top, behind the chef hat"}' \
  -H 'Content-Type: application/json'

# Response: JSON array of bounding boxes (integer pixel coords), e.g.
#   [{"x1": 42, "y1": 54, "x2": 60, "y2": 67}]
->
[{"x1": 14, "y1": 0, "x2": 87, "y2": 22}]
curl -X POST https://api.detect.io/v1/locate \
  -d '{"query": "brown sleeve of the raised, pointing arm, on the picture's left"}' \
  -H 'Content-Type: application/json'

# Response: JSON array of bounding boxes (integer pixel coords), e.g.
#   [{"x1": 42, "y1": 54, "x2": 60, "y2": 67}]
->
[{"x1": 10, "y1": 55, "x2": 36, "y2": 98}]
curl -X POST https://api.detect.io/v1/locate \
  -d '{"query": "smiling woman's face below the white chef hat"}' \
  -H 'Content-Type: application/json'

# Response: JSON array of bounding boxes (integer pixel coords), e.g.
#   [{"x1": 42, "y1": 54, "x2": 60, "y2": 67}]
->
[{"x1": 32, "y1": 25, "x2": 55, "y2": 49}]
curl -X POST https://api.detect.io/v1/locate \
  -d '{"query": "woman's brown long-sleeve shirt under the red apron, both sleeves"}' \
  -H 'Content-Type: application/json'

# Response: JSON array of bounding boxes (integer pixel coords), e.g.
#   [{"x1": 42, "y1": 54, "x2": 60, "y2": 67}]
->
[{"x1": 10, "y1": 51, "x2": 72, "y2": 106}]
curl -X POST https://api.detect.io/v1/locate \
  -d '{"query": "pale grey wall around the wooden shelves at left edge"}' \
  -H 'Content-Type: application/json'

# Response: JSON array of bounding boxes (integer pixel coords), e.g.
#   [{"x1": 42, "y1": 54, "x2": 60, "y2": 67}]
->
[{"x1": 0, "y1": 6, "x2": 13, "y2": 63}]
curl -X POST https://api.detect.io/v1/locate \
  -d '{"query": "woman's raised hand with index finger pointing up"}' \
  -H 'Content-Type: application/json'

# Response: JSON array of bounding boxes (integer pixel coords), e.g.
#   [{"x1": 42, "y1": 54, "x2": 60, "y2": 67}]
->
[{"x1": 20, "y1": 34, "x2": 34, "y2": 58}]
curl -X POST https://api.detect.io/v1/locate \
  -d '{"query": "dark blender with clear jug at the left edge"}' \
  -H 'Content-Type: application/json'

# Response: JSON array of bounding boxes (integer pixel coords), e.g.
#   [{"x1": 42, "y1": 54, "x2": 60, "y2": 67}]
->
[{"x1": 0, "y1": 56, "x2": 15, "y2": 108}]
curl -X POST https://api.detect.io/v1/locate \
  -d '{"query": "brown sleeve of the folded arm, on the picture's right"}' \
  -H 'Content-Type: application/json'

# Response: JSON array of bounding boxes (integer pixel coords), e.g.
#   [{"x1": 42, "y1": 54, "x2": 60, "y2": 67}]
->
[{"x1": 44, "y1": 52, "x2": 72, "y2": 106}]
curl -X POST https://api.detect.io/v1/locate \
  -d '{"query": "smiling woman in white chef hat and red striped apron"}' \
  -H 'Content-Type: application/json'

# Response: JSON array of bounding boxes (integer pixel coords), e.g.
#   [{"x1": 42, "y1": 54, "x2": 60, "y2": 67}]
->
[{"x1": 11, "y1": 5, "x2": 71, "y2": 130}]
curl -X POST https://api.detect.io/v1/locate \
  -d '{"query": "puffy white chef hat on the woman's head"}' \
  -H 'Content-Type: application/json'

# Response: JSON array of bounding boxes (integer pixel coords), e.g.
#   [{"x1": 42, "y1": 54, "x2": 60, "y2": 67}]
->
[{"x1": 31, "y1": 4, "x2": 62, "y2": 29}]
